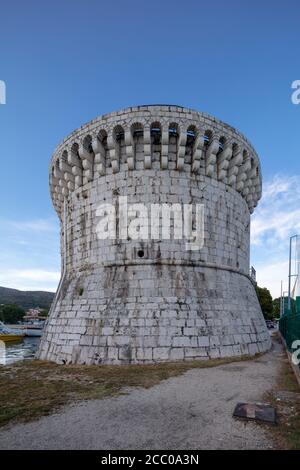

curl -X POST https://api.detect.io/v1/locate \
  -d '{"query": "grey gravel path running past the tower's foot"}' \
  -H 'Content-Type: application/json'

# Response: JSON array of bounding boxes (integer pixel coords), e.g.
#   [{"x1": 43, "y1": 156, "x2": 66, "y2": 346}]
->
[{"x1": 0, "y1": 336, "x2": 283, "y2": 450}]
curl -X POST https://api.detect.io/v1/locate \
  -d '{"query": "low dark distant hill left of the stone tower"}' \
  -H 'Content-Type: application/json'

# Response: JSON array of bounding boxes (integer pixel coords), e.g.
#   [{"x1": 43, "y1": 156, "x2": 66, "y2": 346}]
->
[{"x1": 0, "y1": 286, "x2": 55, "y2": 310}]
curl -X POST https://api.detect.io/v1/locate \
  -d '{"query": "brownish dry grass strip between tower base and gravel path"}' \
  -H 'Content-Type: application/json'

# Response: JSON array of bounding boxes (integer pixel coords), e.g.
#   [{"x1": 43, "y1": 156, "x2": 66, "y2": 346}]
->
[{"x1": 0, "y1": 356, "x2": 257, "y2": 426}]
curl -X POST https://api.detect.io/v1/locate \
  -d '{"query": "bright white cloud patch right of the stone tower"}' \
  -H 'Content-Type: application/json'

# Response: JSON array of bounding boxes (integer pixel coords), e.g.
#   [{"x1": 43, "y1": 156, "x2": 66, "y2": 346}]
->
[{"x1": 251, "y1": 174, "x2": 300, "y2": 297}]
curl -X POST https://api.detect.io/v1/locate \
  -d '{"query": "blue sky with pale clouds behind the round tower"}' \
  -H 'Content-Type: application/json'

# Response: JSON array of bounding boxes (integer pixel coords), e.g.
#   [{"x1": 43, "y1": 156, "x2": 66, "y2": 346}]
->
[{"x1": 0, "y1": 0, "x2": 300, "y2": 295}]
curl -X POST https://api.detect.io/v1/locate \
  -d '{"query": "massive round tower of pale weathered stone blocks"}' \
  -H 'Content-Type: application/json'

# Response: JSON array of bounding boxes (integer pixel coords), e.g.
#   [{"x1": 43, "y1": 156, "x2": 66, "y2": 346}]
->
[{"x1": 38, "y1": 105, "x2": 270, "y2": 364}]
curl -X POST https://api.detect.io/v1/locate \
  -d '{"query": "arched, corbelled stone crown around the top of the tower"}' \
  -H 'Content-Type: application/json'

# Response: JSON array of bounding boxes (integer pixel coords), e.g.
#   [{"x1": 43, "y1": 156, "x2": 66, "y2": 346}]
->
[{"x1": 50, "y1": 105, "x2": 261, "y2": 216}]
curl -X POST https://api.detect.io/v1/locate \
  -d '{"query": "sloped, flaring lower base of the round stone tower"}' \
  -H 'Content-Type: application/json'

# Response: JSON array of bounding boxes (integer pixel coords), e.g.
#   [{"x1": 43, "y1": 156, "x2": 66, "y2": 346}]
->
[{"x1": 40, "y1": 264, "x2": 270, "y2": 364}]
